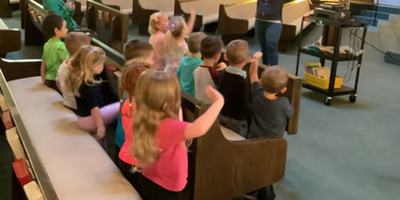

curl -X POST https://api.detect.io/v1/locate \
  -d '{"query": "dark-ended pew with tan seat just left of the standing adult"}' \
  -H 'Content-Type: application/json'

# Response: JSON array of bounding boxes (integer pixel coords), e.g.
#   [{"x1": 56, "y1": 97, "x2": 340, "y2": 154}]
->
[{"x1": 217, "y1": 0, "x2": 257, "y2": 44}]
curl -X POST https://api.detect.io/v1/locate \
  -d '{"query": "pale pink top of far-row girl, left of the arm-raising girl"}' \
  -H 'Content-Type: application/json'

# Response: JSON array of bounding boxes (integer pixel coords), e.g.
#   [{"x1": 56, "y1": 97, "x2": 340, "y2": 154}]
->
[{"x1": 149, "y1": 32, "x2": 165, "y2": 70}]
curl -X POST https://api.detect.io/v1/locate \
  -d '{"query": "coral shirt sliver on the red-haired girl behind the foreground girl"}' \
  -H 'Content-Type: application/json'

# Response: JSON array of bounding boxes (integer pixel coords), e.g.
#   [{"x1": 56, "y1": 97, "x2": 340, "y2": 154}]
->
[{"x1": 118, "y1": 100, "x2": 138, "y2": 165}]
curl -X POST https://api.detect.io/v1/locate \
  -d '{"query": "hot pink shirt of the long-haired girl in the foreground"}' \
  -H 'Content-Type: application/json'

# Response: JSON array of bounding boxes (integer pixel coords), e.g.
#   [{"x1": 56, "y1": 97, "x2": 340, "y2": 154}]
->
[{"x1": 142, "y1": 118, "x2": 189, "y2": 192}]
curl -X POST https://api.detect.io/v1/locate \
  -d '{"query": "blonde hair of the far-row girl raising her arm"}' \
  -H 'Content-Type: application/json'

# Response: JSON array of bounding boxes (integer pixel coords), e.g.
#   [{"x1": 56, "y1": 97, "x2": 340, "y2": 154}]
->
[{"x1": 164, "y1": 16, "x2": 186, "y2": 57}]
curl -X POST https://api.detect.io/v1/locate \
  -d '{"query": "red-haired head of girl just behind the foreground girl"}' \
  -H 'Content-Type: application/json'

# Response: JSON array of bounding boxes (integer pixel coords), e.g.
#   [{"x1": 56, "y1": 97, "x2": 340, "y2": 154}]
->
[{"x1": 119, "y1": 61, "x2": 151, "y2": 102}]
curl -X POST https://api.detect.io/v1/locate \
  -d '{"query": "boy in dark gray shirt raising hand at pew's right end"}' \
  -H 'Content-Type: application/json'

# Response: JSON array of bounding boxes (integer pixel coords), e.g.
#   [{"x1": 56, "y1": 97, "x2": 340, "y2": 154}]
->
[{"x1": 248, "y1": 57, "x2": 294, "y2": 199}]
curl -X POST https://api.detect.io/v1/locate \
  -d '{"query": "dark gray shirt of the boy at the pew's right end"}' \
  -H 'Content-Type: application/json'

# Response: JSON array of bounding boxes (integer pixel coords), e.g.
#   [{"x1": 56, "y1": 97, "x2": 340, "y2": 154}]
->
[{"x1": 248, "y1": 82, "x2": 293, "y2": 138}]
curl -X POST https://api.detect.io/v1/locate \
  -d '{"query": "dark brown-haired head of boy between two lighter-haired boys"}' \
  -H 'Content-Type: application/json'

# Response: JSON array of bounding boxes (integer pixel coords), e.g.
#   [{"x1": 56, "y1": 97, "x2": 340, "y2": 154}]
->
[{"x1": 200, "y1": 36, "x2": 224, "y2": 60}]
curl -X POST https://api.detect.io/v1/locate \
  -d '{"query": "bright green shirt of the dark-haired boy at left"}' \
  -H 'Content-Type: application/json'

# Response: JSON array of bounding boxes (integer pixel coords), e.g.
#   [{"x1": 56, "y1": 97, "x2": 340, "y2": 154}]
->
[{"x1": 42, "y1": 38, "x2": 69, "y2": 81}]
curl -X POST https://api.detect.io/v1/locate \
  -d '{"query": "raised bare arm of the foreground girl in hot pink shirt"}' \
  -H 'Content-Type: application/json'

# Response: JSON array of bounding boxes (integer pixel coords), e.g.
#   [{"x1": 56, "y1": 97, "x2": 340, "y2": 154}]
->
[{"x1": 185, "y1": 85, "x2": 224, "y2": 139}]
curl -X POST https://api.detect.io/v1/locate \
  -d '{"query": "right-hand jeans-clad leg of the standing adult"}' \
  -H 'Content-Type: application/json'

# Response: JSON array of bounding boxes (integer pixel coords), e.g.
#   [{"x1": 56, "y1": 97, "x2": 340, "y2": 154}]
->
[{"x1": 263, "y1": 22, "x2": 282, "y2": 66}]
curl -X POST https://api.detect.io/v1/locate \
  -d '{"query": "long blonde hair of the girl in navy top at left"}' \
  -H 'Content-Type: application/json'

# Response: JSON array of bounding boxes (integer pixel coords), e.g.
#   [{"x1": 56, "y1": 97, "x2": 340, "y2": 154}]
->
[{"x1": 65, "y1": 46, "x2": 106, "y2": 97}]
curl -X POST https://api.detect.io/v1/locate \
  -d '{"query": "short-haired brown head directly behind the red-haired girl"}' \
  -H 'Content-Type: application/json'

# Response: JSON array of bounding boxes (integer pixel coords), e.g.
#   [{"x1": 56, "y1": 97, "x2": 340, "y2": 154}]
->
[{"x1": 124, "y1": 39, "x2": 154, "y2": 65}]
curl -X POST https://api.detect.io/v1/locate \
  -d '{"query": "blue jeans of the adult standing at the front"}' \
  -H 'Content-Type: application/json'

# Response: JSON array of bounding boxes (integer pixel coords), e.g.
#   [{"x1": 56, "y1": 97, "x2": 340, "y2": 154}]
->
[{"x1": 255, "y1": 20, "x2": 282, "y2": 66}]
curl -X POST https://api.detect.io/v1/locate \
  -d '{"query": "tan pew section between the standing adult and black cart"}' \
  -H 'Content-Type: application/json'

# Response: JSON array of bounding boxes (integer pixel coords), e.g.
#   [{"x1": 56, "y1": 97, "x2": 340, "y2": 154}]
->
[{"x1": 282, "y1": 0, "x2": 311, "y2": 23}]
